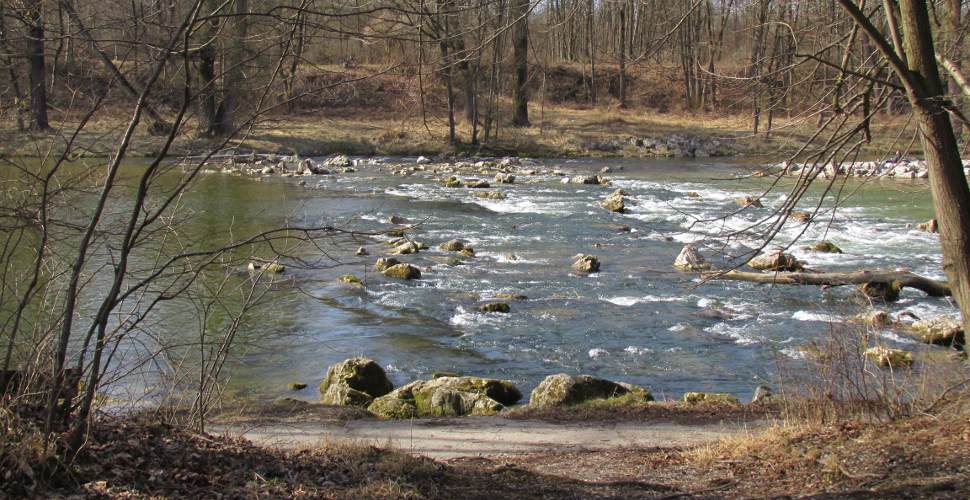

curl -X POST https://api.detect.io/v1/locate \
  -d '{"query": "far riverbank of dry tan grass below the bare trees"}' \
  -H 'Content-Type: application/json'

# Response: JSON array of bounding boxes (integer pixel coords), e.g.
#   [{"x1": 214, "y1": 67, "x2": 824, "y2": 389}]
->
[{"x1": 0, "y1": 106, "x2": 907, "y2": 161}]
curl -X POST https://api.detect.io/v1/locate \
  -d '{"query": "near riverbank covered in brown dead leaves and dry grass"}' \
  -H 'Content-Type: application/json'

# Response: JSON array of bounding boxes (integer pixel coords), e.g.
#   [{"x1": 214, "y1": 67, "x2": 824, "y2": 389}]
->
[{"x1": 0, "y1": 403, "x2": 970, "y2": 499}]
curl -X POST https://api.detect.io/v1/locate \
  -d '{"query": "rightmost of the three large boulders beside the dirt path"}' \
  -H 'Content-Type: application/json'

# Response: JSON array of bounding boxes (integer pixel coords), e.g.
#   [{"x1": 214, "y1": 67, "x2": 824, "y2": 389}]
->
[{"x1": 529, "y1": 373, "x2": 653, "y2": 407}]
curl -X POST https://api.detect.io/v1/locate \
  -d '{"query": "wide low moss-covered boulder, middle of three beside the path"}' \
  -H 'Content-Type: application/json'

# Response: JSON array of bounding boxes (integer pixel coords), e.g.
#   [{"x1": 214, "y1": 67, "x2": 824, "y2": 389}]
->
[{"x1": 367, "y1": 377, "x2": 522, "y2": 419}]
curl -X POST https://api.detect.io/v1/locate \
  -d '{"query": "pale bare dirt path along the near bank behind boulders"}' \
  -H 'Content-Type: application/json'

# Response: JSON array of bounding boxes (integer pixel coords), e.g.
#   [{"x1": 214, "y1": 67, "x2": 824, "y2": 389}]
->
[{"x1": 210, "y1": 417, "x2": 758, "y2": 459}]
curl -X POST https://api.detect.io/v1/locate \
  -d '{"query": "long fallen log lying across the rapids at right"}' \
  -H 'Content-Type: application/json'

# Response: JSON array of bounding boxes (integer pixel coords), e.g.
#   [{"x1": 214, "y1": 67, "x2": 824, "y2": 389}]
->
[{"x1": 703, "y1": 271, "x2": 950, "y2": 297}]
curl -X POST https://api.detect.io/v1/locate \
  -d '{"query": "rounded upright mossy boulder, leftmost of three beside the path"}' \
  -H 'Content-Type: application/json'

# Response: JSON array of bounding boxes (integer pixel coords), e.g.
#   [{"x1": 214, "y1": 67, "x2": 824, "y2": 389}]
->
[{"x1": 320, "y1": 358, "x2": 394, "y2": 406}]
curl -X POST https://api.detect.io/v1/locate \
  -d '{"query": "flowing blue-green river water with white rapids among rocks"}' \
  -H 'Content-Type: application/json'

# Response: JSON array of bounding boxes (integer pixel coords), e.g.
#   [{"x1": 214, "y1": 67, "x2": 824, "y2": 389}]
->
[{"x1": 9, "y1": 159, "x2": 954, "y2": 400}]
